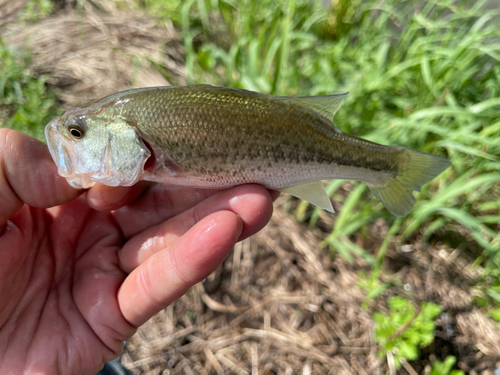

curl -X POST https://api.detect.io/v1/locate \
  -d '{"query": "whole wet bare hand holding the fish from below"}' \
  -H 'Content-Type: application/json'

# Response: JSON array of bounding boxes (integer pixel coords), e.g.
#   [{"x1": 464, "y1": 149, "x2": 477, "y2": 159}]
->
[{"x1": 0, "y1": 129, "x2": 276, "y2": 374}]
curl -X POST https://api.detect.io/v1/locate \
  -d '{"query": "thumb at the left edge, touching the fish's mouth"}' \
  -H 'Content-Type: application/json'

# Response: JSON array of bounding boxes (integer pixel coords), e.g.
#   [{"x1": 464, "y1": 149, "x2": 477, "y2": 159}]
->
[{"x1": 0, "y1": 128, "x2": 81, "y2": 227}]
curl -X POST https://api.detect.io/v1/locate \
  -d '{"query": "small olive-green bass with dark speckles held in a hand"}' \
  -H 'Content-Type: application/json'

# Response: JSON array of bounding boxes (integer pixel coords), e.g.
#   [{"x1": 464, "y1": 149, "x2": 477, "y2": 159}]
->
[{"x1": 45, "y1": 85, "x2": 450, "y2": 216}]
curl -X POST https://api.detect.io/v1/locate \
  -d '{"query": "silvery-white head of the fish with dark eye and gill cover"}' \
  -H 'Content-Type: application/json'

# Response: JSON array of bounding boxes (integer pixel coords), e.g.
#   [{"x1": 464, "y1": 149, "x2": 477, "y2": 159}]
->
[{"x1": 45, "y1": 106, "x2": 151, "y2": 189}]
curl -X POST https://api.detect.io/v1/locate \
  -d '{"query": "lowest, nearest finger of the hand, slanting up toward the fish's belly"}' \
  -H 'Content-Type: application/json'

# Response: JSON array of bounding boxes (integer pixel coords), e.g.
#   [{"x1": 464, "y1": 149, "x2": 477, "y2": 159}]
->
[{"x1": 117, "y1": 211, "x2": 242, "y2": 327}]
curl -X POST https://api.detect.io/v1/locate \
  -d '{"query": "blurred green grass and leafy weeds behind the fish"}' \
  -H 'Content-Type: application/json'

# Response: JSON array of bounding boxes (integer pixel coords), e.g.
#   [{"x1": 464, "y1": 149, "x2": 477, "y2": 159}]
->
[{"x1": 0, "y1": 0, "x2": 500, "y2": 374}]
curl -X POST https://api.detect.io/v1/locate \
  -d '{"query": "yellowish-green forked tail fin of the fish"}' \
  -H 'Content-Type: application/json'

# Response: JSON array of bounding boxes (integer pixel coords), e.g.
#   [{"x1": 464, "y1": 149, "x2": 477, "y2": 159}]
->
[{"x1": 368, "y1": 149, "x2": 451, "y2": 216}]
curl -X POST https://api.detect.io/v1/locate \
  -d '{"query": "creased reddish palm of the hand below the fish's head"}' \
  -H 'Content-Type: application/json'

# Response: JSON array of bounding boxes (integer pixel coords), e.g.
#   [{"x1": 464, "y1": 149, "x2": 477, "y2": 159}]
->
[{"x1": 0, "y1": 199, "x2": 129, "y2": 374}]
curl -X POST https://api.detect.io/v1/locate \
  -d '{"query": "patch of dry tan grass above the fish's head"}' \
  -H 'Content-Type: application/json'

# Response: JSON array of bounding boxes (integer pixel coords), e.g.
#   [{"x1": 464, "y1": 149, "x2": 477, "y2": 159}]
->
[{"x1": 0, "y1": 1, "x2": 186, "y2": 107}]
